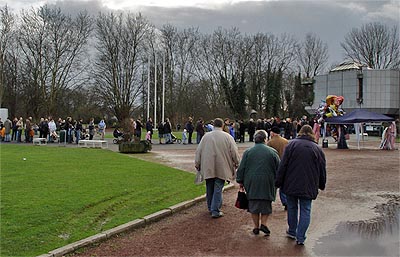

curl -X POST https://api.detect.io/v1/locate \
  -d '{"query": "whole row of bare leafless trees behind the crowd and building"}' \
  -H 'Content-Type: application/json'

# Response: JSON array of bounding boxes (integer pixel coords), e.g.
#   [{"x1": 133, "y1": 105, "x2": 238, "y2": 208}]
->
[{"x1": 0, "y1": 5, "x2": 400, "y2": 123}]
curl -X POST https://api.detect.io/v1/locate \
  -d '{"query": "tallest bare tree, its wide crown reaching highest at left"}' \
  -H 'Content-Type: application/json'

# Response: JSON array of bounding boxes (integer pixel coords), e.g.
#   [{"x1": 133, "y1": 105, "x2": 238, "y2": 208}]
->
[{"x1": 18, "y1": 5, "x2": 91, "y2": 117}]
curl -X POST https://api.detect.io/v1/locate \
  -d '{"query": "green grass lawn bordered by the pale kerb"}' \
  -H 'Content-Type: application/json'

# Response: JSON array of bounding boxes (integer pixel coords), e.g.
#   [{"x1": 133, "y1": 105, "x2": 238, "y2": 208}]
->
[{"x1": 0, "y1": 144, "x2": 205, "y2": 256}]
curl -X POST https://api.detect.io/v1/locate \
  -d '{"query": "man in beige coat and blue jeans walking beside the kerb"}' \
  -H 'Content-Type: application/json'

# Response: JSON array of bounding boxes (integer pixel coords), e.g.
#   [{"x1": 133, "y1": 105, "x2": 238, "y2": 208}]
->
[{"x1": 195, "y1": 118, "x2": 240, "y2": 218}]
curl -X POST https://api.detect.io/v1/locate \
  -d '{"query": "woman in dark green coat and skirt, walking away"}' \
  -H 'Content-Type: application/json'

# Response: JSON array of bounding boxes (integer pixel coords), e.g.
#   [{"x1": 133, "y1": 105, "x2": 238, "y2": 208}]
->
[{"x1": 236, "y1": 130, "x2": 280, "y2": 236}]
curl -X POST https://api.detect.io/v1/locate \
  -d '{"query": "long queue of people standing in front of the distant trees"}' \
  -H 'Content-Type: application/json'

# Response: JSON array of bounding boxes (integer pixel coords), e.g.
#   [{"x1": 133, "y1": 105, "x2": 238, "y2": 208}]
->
[{"x1": 0, "y1": 116, "x2": 315, "y2": 144}]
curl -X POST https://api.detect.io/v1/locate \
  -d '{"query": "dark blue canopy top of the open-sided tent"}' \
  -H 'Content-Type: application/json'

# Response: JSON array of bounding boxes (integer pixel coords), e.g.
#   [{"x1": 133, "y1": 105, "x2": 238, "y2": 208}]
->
[{"x1": 325, "y1": 109, "x2": 394, "y2": 124}]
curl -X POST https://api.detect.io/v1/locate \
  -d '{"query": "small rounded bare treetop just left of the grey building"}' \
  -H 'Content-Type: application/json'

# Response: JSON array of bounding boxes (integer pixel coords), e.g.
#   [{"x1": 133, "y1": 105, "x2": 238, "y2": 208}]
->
[{"x1": 297, "y1": 33, "x2": 329, "y2": 78}]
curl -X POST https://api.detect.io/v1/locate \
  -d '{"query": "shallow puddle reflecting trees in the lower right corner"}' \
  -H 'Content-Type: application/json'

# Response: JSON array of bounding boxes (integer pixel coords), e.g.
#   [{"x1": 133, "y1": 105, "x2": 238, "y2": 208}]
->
[{"x1": 314, "y1": 195, "x2": 400, "y2": 256}]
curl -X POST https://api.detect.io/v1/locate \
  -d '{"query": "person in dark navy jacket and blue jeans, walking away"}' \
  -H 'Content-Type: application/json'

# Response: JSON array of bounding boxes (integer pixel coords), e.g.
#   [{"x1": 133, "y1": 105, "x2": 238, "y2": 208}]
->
[{"x1": 275, "y1": 125, "x2": 326, "y2": 245}]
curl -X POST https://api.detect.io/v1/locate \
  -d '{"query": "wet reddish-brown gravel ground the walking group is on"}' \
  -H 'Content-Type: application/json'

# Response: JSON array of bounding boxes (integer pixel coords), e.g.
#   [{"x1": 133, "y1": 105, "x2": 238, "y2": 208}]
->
[{"x1": 70, "y1": 138, "x2": 400, "y2": 256}]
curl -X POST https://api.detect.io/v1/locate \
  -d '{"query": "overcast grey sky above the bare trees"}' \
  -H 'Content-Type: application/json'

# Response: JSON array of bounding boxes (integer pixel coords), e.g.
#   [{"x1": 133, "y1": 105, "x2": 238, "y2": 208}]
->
[{"x1": 0, "y1": 0, "x2": 400, "y2": 66}]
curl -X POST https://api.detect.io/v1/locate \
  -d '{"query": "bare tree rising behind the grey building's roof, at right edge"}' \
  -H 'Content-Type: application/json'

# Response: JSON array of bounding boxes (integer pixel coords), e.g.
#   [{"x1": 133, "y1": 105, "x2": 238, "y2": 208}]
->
[{"x1": 340, "y1": 22, "x2": 400, "y2": 69}]
